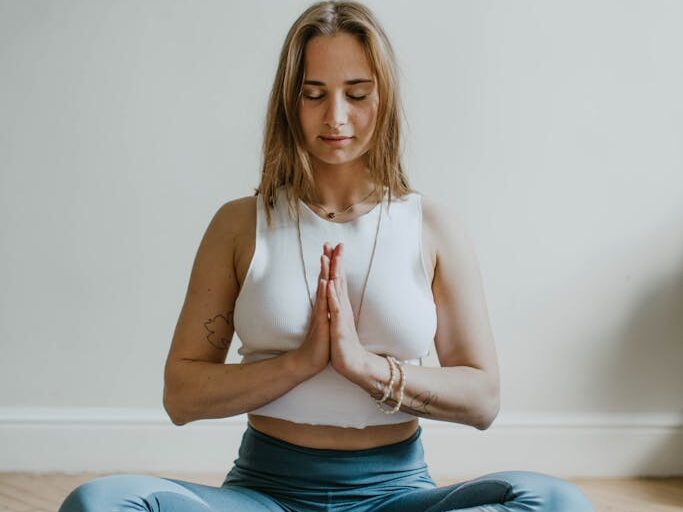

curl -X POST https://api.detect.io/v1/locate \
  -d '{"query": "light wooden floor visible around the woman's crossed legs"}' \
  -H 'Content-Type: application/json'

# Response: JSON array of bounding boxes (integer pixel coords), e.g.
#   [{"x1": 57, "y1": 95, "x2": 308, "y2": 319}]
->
[{"x1": 0, "y1": 473, "x2": 683, "y2": 512}]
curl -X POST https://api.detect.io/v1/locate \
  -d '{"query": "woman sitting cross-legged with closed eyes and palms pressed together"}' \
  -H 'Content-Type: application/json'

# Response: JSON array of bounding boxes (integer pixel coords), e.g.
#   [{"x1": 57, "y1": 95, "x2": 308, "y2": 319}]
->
[{"x1": 60, "y1": 2, "x2": 593, "y2": 512}]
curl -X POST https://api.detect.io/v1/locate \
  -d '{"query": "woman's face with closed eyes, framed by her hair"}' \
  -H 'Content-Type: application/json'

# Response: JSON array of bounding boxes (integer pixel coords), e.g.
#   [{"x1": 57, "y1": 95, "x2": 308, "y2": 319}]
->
[{"x1": 299, "y1": 33, "x2": 379, "y2": 169}]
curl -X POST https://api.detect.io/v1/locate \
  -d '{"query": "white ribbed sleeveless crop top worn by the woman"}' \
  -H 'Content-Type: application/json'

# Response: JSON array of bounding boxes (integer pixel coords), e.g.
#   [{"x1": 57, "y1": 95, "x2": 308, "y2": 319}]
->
[{"x1": 233, "y1": 187, "x2": 436, "y2": 428}]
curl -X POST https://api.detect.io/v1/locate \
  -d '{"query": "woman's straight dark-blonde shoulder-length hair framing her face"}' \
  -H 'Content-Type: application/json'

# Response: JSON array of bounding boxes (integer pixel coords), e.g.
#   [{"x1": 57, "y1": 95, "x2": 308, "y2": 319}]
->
[{"x1": 254, "y1": 0, "x2": 413, "y2": 225}]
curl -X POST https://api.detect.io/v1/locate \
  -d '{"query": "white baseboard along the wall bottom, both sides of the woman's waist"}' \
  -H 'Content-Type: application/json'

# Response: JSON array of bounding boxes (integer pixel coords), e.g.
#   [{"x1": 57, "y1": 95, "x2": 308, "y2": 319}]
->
[{"x1": 0, "y1": 407, "x2": 683, "y2": 479}]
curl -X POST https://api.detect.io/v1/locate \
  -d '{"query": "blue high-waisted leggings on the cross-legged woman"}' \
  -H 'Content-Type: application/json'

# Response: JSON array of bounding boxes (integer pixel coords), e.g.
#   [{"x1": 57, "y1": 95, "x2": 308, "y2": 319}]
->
[{"x1": 58, "y1": 424, "x2": 594, "y2": 512}]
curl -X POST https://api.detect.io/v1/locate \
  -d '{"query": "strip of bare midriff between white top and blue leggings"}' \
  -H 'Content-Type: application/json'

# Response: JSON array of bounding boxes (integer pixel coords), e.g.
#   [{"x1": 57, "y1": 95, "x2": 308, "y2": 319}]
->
[{"x1": 247, "y1": 414, "x2": 419, "y2": 450}]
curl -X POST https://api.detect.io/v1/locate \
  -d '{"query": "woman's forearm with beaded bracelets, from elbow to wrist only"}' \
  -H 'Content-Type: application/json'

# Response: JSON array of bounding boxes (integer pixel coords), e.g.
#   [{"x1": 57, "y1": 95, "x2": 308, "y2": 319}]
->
[{"x1": 352, "y1": 353, "x2": 499, "y2": 430}]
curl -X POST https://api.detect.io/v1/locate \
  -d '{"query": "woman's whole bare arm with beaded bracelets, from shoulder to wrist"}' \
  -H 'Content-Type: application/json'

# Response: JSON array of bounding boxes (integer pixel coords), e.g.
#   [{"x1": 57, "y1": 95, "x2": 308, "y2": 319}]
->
[{"x1": 344, "y1": 198, "x2": 500, "y2": 430}]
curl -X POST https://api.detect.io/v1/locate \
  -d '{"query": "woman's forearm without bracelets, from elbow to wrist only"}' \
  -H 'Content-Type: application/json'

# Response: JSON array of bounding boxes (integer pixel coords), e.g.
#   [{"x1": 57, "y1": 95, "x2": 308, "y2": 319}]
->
[{"x1": 164, "y1": 352, "x2": 311, "y2": 425}]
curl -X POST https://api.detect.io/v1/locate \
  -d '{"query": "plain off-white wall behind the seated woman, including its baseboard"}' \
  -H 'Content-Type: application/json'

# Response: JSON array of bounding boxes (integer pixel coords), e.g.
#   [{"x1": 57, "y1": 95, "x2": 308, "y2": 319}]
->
[{"x1": 0, "y1": 0, "x2": 683, "y2": 474}]
